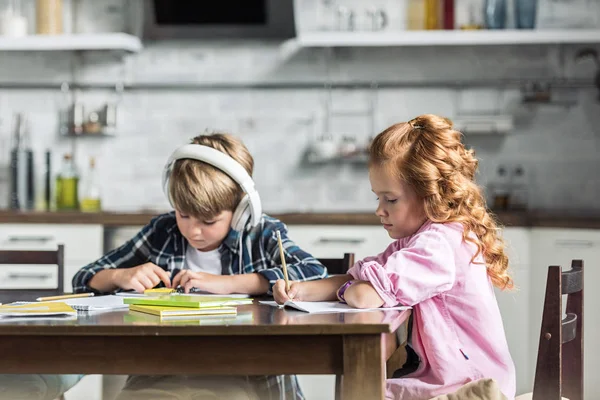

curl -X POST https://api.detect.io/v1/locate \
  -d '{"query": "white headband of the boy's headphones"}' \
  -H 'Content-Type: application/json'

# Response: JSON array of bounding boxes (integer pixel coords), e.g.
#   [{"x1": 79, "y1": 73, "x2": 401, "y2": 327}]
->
[{"x1": 162, "y1": 144, "x2": 262, "y2": 226}]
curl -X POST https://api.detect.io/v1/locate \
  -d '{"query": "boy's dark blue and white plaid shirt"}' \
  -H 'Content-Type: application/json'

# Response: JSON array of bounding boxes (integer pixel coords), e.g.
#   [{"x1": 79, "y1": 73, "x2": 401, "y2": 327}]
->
[{"x1": 73, "y1": 212, "x2": 327, "y2": 400}]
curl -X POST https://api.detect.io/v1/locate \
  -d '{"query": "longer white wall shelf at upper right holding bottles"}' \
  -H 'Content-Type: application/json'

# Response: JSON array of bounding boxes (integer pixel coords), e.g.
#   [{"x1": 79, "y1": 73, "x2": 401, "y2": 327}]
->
[{"x1": 292, "y1": 29, "x2": 600, "y2": 47}]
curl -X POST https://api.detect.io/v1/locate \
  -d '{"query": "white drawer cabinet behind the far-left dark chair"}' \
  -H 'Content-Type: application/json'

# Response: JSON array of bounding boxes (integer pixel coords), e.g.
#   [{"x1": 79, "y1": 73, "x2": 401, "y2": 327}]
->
[{"x1": 0, "y1": 224, "x2": 104, "y2": 292}]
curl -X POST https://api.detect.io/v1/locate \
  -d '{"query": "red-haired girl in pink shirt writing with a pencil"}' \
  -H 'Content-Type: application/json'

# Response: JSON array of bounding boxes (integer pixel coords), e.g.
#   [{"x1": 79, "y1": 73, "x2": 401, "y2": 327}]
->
[{"x1": 273, "y1": 115, "x2": 515, "y2": 400}]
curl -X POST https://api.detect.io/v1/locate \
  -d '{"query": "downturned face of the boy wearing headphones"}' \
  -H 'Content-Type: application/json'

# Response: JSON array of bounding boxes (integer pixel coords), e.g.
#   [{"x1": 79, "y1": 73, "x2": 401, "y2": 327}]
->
[{"x1": 175, "y1": 210, "x2": 233, "y2": 251}]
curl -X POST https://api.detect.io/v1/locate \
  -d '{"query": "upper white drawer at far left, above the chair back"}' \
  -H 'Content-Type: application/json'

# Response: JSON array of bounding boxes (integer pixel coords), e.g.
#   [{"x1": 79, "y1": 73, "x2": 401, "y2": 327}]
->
[{"x1": 0, "y1": 224, "x2": 103, "y2": 262}]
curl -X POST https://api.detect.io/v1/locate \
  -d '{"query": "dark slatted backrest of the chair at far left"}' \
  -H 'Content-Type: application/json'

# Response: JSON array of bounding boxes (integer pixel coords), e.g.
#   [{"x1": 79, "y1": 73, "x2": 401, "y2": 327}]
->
[{"x1": 0, "y1": 244, "x2": 65, "y2": 294}]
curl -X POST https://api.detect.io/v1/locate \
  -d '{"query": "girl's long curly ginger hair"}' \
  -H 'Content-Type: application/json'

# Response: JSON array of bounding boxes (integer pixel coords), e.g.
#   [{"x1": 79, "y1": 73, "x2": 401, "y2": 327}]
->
[{"x1": 369, "y1": 114, "x2": 513, "y2": 289}]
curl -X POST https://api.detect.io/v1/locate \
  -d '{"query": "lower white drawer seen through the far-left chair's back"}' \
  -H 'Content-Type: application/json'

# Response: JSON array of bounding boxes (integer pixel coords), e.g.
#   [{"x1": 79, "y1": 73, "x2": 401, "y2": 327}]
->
[{"x1": 0, "y1": 264, "x2": 58, "y2": 289}]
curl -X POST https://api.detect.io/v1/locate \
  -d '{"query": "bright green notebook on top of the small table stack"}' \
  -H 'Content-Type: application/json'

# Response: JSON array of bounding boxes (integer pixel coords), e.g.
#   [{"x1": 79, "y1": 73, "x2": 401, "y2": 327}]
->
[{"x1": 123, "y1": 295, "x2": 252, "y2": 308}]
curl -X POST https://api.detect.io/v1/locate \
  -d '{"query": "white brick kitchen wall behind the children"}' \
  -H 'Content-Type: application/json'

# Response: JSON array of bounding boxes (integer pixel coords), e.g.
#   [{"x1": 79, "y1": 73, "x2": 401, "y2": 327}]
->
[{"x1": 0, "y1": 5, "x2": 600, "y2": 212}]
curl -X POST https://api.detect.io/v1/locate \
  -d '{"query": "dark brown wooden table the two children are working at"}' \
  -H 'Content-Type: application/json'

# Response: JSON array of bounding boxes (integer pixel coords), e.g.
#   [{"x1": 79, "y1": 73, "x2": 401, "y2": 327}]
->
[{"x1": 0, "y1": 302, "x2": 410, "y2": 400}]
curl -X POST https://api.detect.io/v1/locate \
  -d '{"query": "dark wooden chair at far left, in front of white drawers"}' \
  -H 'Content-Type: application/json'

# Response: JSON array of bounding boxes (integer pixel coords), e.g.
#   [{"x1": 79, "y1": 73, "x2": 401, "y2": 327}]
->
[{"x1": 0, "y1": 244, "x2": 65, "y2": 303}]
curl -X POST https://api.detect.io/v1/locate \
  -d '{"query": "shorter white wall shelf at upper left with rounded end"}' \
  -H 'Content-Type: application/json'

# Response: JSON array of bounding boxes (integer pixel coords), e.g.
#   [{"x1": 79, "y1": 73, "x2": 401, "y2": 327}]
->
[{"x1": 0, "y1": 33, "x2": 142, "y2": 53}]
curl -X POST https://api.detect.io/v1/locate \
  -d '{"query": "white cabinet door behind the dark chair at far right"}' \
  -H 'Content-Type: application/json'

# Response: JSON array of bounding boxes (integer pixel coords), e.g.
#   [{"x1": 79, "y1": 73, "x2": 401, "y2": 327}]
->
[{"x1": 530, "y1": 228, "x2": 600, "y2": 399}]
